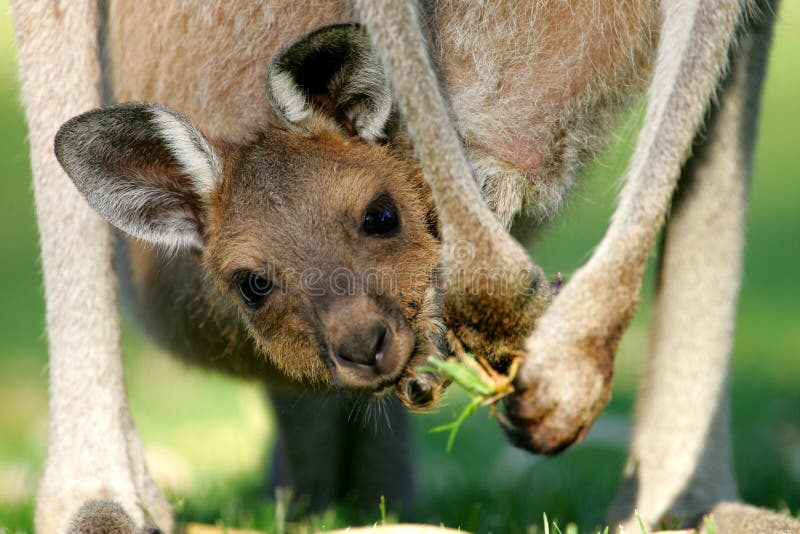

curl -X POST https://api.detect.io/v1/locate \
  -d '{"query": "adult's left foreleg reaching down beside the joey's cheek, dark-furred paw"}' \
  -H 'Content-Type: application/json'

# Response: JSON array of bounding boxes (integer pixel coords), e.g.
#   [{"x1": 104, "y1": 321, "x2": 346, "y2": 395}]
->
[{"x1": 356, "y1": 0, "x2": 553, "y2": 366}]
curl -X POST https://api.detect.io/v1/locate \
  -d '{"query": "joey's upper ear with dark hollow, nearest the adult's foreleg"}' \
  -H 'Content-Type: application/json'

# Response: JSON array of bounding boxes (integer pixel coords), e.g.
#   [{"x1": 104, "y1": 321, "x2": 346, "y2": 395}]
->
[{"x1": 267, "y1": 24, "x2": 397, "y2": 143}]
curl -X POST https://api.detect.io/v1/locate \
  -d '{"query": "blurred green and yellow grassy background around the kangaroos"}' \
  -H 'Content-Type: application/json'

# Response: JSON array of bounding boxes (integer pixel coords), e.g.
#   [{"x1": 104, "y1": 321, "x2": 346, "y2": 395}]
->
[{"x1": 0, "y1": 0, "x2": 800, "y2": 533}]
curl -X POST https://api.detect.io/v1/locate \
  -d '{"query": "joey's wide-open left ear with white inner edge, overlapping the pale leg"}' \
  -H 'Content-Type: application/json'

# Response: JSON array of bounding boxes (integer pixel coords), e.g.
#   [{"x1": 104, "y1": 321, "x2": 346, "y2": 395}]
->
[{"x1": 55, "y1": 103, "x2": 222, "y2": 248}]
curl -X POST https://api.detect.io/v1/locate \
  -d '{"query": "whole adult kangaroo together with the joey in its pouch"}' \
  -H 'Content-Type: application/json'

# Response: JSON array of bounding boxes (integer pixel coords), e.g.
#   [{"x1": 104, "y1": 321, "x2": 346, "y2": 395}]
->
[{"x1": 13, "y1": 0, "x2": 792, "y2": 533}]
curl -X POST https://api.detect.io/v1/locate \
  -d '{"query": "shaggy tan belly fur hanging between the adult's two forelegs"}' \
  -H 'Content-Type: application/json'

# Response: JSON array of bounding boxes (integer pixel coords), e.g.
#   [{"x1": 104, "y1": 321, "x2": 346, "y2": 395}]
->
[{"x1": 429, "y1": 0, "x2": 659, "y2": 226}]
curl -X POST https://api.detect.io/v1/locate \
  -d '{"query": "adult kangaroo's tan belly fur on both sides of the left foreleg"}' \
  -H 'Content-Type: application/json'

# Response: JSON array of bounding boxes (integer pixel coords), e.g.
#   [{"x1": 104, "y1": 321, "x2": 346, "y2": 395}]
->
[{"x1": 107, "y1": 0, "x2": 659, "y2": 227}]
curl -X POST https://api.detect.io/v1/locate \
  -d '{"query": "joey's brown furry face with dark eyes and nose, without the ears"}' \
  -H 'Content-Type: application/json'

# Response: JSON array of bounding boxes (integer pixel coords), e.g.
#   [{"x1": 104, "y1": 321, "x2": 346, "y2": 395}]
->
[{"x1": 203, "y1": 131, "x2": 440, "y2": 398}]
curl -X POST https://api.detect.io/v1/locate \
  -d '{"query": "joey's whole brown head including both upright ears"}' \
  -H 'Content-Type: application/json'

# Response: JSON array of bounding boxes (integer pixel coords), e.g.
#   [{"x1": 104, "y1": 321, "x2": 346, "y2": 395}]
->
[{"x1": 56, "y1": 26, "x2": 443, "y2": 407}]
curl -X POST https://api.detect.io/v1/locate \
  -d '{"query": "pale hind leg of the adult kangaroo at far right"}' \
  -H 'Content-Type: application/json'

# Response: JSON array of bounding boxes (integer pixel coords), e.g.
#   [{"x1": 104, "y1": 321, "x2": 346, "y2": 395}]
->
[{"x1": 613, "y1": 6, "x2": 774, "y2": 532}]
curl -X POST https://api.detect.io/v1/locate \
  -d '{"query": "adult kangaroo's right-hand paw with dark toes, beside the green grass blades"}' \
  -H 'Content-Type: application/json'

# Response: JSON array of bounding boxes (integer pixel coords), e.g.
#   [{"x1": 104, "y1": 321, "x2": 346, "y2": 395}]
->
[{"x1": 500, "y1": 268, "x2": 635, "y2": 454}]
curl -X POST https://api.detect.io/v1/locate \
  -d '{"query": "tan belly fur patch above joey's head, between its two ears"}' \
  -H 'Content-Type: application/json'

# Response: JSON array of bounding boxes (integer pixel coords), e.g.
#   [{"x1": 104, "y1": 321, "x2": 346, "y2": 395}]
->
[{"x1": 108, "y1": 0, "x2": 347, "y2": 142}]
